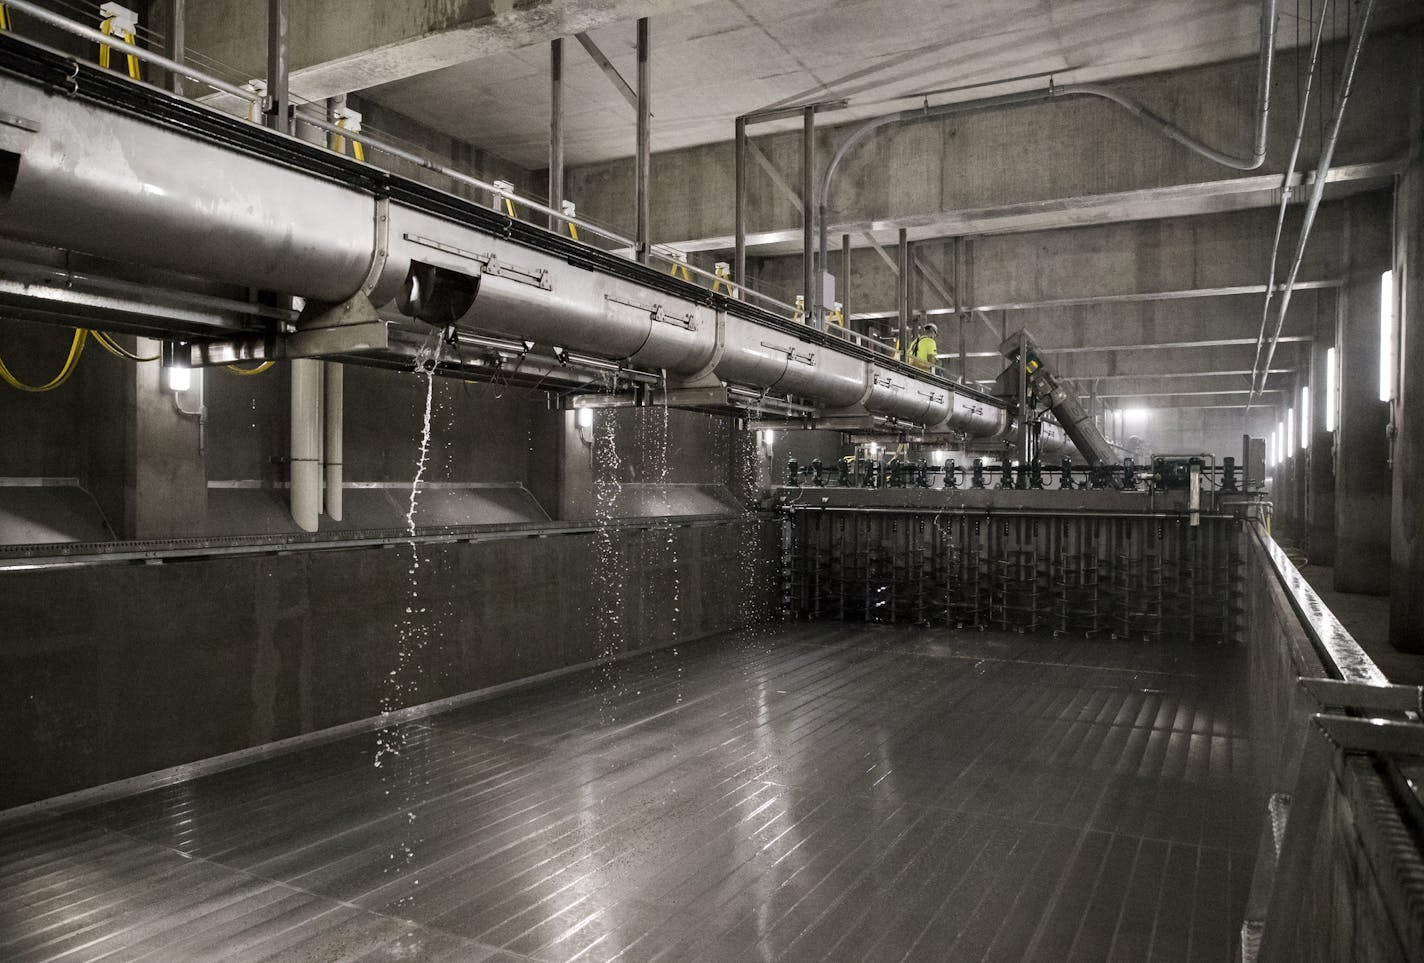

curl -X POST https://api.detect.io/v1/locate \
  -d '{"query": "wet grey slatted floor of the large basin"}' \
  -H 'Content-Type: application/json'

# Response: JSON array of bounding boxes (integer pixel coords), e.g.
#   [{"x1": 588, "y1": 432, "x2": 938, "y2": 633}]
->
[{"x1": 0, "y1": 625, "x2": 1256, "y2": 962}]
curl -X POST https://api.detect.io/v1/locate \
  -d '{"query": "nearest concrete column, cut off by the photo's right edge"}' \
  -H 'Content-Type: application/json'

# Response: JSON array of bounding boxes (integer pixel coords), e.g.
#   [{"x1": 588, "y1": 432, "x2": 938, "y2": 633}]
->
[{"x1": 1390, "y1": 152, "x2": 1424, "y2": 652}]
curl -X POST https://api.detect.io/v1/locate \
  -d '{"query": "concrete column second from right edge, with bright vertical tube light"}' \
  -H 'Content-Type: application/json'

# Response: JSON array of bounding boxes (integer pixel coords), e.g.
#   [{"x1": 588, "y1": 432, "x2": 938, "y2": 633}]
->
[{"x1": 1334, "y1": 195, "x2": 1393, "y2": 595}]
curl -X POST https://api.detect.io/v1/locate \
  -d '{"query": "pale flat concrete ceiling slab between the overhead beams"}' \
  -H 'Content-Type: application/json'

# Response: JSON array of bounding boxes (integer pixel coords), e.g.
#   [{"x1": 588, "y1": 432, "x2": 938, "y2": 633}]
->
[{"x1": 365, "y1": 0, "x2": 1418, "y2": 170}]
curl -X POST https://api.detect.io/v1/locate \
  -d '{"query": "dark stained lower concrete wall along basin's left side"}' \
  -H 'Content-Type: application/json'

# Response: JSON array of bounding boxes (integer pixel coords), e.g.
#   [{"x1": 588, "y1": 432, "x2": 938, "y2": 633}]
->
[{"x1": 0, "y1": 517, "x2": 775, "y2": 808}]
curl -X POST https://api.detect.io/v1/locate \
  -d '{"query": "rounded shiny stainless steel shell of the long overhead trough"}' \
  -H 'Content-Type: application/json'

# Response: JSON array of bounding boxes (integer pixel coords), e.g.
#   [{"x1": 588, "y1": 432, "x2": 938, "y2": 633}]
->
[{"x1": 0, "y1": 72, "x2": 1025, "y2": 449}]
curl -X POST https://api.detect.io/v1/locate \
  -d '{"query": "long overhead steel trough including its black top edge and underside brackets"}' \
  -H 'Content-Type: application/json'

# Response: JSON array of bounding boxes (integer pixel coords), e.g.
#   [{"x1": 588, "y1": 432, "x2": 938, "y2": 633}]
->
[{"x1": 0, "y1": 37, "x2": 1025, "y2": 452}]
